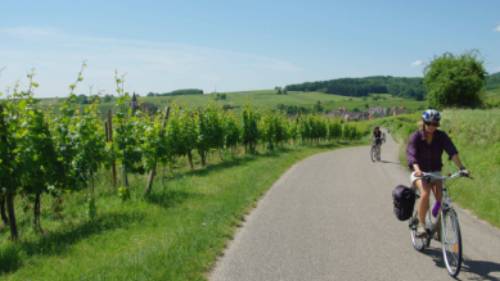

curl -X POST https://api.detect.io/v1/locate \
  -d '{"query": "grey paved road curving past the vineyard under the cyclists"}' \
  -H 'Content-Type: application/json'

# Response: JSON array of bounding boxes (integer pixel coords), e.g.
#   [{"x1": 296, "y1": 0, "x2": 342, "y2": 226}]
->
[{"x1": 209, "y1": 132, "x2": 500, "y2": 281}]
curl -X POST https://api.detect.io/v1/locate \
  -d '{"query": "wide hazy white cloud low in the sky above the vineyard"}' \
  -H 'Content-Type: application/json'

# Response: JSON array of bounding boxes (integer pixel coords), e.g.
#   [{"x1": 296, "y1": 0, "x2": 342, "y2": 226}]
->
[{"x1": 0, "y1": 27, "x2": 303, "y2": 97}]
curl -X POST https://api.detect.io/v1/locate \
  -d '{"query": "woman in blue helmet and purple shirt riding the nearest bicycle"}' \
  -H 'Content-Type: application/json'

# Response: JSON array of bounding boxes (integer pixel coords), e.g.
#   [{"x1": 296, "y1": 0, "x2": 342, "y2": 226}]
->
[{"x1": 406, "y1": 109, "x2": 468, "y2": 236}]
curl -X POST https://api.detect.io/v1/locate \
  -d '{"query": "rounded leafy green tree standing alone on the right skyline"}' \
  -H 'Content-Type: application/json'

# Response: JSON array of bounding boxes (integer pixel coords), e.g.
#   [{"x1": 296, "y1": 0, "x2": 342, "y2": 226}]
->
[{"x1": 424, "y1": 52, "x2": 486, "y2": 108}]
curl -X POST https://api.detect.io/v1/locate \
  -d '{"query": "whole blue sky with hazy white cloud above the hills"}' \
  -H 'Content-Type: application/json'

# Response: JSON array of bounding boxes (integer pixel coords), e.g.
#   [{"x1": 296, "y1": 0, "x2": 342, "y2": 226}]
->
[{"x1": 0, "y1": 0, "x2": 500, "y2": 97}]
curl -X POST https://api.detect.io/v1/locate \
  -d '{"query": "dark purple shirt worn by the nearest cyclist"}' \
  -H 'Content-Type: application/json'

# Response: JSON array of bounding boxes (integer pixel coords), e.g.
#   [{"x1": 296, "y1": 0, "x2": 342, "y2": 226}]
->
[{"x1": 406, "y1": 130, "x2": 458, "y2": 172}]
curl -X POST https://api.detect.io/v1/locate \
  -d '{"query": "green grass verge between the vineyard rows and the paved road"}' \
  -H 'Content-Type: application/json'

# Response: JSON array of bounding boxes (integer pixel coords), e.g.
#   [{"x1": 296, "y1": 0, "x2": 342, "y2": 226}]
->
[{"x1": 0, "y1": 143, "x2": 356, "y2": 281}]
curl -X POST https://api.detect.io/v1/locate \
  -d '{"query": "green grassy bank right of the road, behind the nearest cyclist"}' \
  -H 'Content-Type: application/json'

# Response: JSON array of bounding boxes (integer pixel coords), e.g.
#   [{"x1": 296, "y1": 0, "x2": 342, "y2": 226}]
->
[{"x1": 377, "y1": 108, "x2": 500, "y2": 227}]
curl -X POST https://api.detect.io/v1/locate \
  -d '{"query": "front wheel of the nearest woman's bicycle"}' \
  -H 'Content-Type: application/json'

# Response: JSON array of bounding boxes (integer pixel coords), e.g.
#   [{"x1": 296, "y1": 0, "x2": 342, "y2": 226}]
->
[{"x1": 441, "y1": 209, "x2": 462, "y2": 277}]
